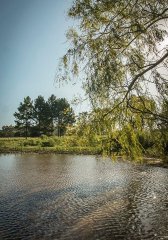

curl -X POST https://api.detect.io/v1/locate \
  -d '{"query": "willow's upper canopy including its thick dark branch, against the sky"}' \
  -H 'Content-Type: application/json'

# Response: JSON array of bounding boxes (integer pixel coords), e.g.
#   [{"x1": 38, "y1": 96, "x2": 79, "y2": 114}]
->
[{"x1": 62, "y1": 0, "x2": 168, "y2": 122}]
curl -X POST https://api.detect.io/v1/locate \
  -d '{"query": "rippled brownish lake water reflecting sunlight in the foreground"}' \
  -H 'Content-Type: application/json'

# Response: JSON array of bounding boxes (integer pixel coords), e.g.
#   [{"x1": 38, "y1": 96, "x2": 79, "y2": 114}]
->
[{"x1": 0, "y1": 154, "x2": 168, "y2": 240}]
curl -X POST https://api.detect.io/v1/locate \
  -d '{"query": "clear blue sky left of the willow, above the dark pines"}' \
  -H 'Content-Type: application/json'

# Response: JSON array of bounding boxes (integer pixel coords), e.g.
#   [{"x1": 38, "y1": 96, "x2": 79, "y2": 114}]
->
[{"x1": 0, "y1": 0, "x2": 87, "y2": 128}]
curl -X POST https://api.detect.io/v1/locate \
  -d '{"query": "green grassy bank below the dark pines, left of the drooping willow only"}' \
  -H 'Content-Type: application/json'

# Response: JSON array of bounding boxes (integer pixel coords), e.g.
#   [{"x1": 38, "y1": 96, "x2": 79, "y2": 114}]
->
[{"x1": 0, "y1": 136, "x2": 101, "y2": 154}]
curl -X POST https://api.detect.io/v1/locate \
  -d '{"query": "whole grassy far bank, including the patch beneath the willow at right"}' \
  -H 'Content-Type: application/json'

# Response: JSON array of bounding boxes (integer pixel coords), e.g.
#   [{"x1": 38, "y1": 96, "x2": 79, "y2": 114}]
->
[{"x1": 0, "y1": 136, "x2": 168, "y2": 166}]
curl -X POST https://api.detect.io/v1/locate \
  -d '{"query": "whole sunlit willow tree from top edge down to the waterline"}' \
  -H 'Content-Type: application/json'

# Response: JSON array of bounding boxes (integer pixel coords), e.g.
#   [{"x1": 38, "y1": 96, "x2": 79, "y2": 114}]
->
[{"x1": 57, "y1": 0, "x2": 168, "y2": 159}]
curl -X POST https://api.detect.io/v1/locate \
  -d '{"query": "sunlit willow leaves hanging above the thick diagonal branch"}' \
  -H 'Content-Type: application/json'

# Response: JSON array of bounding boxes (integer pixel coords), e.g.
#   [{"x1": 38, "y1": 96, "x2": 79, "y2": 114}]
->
[{"x1": 63, "y1": 0, "x2": 168, "y2": 108}]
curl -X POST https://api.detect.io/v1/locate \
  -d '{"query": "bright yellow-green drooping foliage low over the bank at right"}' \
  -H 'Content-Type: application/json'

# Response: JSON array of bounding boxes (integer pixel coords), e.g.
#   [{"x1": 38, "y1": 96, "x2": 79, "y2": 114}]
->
[{"x1": 67, "y1": 104, "x2": 168, "y2": 160}]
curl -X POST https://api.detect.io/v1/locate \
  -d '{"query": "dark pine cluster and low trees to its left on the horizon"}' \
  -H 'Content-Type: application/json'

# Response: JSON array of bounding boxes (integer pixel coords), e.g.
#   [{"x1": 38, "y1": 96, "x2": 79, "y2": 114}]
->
[{"x1": 0, "y1": 95, "x2": 75, "y2": 137}]
